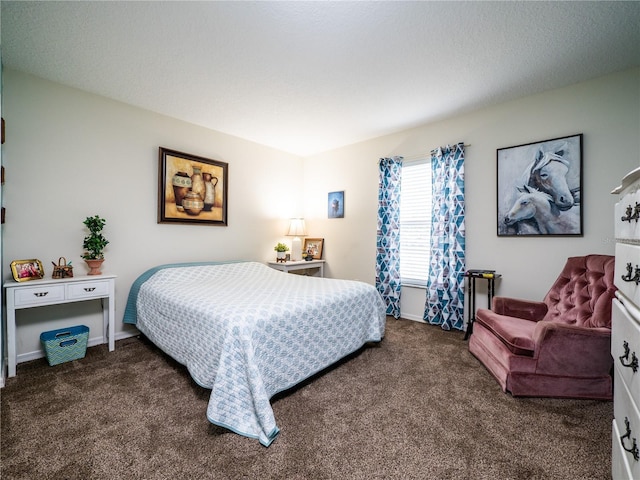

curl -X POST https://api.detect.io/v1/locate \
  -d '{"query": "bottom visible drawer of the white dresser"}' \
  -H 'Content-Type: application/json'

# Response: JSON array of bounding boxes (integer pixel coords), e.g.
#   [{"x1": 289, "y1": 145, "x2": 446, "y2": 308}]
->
[{"x1": 611, "y1": 366, "x2": 640, "y2": 478}]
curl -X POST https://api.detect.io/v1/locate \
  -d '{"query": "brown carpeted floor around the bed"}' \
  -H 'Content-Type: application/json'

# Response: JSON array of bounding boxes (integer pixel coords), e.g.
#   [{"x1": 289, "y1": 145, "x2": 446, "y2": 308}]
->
[{"x1": 0, "y1": 318, "x2": 613, "y2": 480}]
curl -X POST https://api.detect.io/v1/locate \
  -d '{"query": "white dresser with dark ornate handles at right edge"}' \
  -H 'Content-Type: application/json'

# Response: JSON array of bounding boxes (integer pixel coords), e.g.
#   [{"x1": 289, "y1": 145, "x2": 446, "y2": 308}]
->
[{"x1": 611, "y1": 168, "x2": 640, "y2": 480}]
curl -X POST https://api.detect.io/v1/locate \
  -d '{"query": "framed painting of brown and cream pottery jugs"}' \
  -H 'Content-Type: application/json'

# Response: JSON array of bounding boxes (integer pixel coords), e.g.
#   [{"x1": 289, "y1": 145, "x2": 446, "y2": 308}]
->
[{"x1": 158, "y1": 147, "x2": 229, "y2": 227}]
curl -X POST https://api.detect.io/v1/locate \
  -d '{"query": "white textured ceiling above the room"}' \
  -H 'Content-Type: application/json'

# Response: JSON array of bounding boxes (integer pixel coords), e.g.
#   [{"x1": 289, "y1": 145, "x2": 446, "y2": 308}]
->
[{"x1": 1, "y1": 0, "x2": 640, "y2": 156}]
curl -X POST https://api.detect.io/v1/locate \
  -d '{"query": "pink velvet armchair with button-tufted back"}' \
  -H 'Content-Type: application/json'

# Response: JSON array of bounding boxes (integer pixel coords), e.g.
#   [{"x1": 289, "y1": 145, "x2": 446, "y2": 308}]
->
[{"x1": 469, "y1": 255, "x2": 616, "y2": 400}]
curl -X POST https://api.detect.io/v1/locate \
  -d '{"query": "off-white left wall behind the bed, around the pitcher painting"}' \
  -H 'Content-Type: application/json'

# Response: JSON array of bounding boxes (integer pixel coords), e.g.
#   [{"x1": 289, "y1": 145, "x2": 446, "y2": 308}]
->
[{"x1": 3, "y1": 70, "x2": 303, "y2": 354}]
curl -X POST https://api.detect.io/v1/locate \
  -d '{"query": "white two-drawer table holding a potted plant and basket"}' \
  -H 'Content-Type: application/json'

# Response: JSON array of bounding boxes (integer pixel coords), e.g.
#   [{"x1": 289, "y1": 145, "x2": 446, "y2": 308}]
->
[{"x1": 4, "y1": 274, "x2": 116, "y2": 377}]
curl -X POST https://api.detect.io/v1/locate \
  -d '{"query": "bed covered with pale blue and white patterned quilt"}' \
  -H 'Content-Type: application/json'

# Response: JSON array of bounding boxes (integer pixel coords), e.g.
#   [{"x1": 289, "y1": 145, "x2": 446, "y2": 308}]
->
[{"x1": 123, "y1": 262, "x2": 386, "y2": 446}]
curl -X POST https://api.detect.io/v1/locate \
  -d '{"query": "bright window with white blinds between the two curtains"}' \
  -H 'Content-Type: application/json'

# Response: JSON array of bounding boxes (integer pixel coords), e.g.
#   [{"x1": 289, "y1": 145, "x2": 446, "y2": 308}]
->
[{"x1": 400, "y1": 159, "x2": 431, "y2": 287}]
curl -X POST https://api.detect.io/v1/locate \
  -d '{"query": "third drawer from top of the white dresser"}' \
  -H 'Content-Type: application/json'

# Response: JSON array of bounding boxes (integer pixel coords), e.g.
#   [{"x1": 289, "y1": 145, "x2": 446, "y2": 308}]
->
[{"x1": 611, "y1": 299, "x2": 640, "y2": 399}]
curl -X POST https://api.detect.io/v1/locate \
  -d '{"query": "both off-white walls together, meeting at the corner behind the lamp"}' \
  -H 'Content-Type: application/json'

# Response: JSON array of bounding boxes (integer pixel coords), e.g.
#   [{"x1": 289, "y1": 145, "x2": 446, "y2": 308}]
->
[{"x1": 2, "y1": 69, "x2": 640, "y2": 355}]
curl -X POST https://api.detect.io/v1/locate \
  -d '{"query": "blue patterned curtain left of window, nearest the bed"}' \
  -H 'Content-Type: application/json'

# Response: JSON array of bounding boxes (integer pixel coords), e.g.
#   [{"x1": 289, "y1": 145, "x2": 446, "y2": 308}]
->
[{"x1": 376, "y1": 157, "x2": 402, "y2": 318}]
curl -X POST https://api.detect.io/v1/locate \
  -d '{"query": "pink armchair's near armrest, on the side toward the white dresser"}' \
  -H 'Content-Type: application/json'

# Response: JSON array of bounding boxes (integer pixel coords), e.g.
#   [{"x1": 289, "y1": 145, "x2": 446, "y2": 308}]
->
[{"x1": 533, "y1": 321, "x2": 613, "y2": 377}]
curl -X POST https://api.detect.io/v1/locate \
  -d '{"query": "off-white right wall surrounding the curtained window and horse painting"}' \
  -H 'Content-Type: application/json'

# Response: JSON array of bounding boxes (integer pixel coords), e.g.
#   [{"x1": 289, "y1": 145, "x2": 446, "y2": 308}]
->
[{"x1": 305, "y1": 69, "x2": 640, "y2": 319}]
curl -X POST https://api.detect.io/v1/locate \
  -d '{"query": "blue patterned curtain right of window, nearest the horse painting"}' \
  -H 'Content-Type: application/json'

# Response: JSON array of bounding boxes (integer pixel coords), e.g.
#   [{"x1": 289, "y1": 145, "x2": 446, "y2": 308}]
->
[{"x1": 423, "y1": 143, "x2": 465, "y2": 330}]
